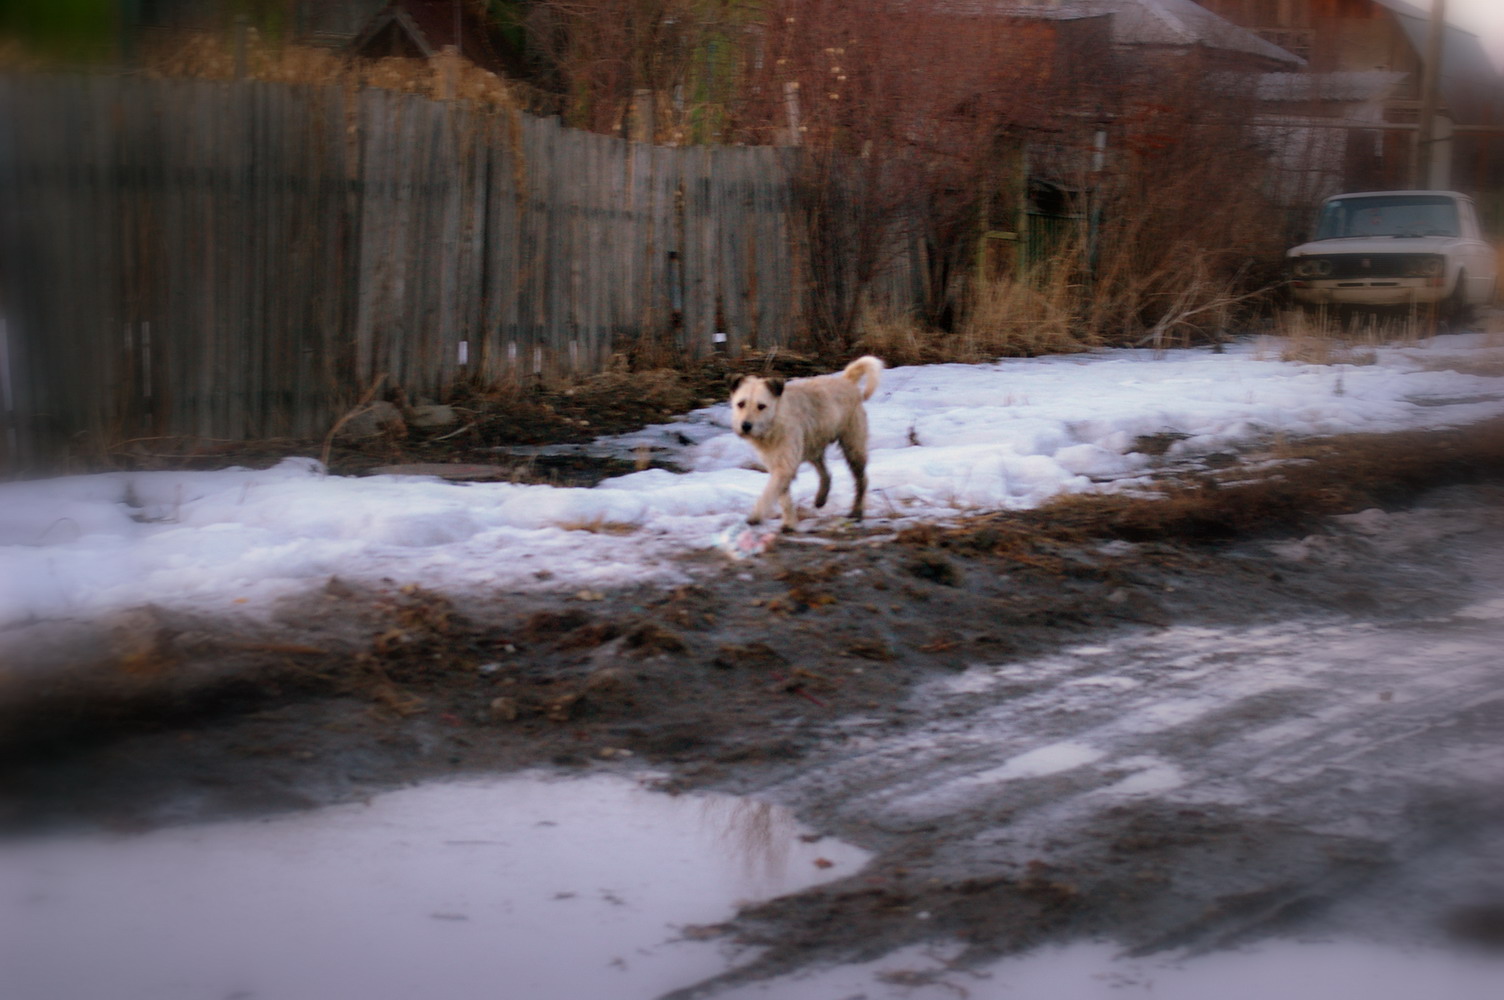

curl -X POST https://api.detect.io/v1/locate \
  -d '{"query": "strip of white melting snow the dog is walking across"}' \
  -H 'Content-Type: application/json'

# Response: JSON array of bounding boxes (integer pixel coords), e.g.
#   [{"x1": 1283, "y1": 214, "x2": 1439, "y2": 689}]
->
[{"x1": 0, "y1": 334, "x2": 1504, "y2": 629}]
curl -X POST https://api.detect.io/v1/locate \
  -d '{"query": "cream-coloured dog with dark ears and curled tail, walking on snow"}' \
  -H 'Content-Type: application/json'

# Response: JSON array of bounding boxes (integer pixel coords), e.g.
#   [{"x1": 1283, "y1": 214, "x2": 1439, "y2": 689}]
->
[{"x1": 731, "y1": 355, "x2": 883, "y2": 531}]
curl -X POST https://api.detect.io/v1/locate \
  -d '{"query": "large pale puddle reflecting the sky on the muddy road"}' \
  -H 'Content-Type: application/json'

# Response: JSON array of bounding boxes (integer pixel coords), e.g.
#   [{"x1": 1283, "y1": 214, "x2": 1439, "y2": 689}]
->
[{"x1": 0, "y1": 776, "x2": 868, "y2": 1000}]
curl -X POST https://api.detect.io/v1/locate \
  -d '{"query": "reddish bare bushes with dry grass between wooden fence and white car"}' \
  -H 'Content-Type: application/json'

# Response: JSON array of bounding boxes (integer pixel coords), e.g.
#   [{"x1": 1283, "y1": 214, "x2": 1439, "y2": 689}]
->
[{"x1": 738, "y1": 0, "x2": 1286, "y2": 358}]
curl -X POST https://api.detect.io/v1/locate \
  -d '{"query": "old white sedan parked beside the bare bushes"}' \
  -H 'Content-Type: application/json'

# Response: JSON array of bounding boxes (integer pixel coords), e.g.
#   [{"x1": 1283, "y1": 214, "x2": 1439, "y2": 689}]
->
[{"x1": 1284, "y1": 191, "x2": 1498, "y2": 322}]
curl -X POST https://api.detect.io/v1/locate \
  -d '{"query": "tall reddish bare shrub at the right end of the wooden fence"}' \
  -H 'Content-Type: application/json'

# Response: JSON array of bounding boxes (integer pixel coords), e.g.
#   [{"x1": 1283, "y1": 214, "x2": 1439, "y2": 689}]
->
[{"x1": 734, "y1": 0, "x2": 1088, "y2": 352}]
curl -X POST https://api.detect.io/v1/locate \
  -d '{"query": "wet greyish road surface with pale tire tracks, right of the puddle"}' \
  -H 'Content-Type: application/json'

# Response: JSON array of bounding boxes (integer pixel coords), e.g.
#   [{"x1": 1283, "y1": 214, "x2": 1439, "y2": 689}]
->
[{"x1": 688, "y1": 492, "x2": 1504, "y2": 992}]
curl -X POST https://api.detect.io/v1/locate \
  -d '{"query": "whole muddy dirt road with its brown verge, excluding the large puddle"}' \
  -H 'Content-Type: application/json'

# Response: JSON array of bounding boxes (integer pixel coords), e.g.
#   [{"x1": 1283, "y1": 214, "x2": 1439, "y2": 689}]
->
[{"x1": 0, "y1": 424, "x2": 1504, "y2": 995}]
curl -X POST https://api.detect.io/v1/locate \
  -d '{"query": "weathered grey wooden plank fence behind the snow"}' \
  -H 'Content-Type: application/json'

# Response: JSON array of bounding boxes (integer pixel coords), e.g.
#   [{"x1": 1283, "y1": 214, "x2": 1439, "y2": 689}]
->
[{"x1": 0, "y1": 77, "x2": 913, "y2": 463}]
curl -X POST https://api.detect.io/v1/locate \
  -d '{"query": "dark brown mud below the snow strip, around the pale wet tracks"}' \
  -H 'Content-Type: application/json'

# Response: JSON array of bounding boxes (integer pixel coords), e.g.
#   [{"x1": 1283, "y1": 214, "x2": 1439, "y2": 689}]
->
[{"x1": 0, "y1": 409, "x2": 1504, "y2": 992}]
